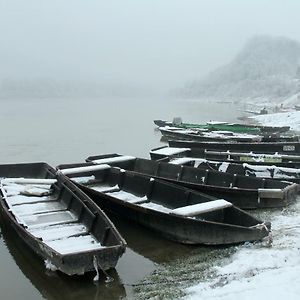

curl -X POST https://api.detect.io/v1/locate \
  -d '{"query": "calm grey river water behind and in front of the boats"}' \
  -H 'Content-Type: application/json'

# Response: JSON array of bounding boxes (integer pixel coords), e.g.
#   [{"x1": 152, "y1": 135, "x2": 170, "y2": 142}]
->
[{"x1": 0, "y1": 98, "x2": 238, "y2": 300}]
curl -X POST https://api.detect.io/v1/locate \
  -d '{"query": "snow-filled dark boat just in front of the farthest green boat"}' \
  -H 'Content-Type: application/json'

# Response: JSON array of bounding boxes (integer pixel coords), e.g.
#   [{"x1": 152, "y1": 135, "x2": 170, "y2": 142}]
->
[{"x1": 159, "y1": 127, "x2": 299, "y2": 142}]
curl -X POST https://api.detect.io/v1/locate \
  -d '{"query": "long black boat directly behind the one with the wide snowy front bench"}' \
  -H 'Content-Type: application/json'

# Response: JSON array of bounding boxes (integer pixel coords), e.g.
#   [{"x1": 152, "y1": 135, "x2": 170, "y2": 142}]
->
[{"x1": 82, "y1": 154, "x2": 299, "y2": 209}]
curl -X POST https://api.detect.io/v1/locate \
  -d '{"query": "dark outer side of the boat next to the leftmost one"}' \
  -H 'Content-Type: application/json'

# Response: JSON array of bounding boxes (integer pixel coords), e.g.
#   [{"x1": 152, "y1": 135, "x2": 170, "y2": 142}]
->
[{"x1": 81, "y1": 186, "x2": 267, "y2": 245}]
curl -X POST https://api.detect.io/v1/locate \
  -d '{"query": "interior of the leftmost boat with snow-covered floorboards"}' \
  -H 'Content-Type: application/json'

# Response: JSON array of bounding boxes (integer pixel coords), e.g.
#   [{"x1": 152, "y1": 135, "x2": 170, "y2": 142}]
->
[{"x1": 0, "y1": 164, "x2": 122, "y2": 255}]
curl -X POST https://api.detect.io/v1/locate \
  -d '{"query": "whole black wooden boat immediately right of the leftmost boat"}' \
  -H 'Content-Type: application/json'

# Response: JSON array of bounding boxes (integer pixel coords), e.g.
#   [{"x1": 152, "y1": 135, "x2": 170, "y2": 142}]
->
[{"x1": 58, "y1": 163, "x2": 270, "y2": 245}]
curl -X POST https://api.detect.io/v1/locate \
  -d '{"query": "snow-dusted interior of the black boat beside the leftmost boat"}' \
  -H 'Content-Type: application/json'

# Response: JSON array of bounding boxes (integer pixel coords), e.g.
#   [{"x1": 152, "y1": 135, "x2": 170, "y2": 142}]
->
[{"x1": 58, "y1": 164, "x2": 256, "y2": 226}]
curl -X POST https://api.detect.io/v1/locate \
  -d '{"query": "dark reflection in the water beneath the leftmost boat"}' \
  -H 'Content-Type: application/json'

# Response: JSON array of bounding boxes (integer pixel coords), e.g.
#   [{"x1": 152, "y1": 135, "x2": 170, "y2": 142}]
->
[{"x1": 0, "y1": 220, "x2": 126, "y2": 300}]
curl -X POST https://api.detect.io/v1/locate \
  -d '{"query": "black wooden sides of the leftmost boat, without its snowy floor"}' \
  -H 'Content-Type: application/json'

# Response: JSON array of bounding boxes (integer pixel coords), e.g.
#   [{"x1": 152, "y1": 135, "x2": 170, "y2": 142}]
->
[{"x1": 0, "y1": 163, "x2": 126, "y2": 275}]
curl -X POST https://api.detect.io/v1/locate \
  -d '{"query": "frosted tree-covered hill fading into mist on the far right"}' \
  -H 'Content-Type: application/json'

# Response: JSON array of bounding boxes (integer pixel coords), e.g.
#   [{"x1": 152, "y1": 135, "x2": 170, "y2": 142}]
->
[{"x1": 183, "y1": 36, "x2": 300, "y2": 102}]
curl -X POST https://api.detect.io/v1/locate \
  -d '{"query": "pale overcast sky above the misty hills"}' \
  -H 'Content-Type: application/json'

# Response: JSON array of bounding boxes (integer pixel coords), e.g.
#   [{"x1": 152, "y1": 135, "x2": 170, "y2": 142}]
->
[{"x1": 0, "y1": 0, "x2": 300, "y2": 89}]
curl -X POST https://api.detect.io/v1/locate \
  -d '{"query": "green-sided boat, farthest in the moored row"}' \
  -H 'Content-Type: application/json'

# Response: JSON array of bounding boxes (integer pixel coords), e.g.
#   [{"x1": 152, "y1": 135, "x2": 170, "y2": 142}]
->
[{"x1": 154, "y1": 120, "x2": 290, "y2": 134}]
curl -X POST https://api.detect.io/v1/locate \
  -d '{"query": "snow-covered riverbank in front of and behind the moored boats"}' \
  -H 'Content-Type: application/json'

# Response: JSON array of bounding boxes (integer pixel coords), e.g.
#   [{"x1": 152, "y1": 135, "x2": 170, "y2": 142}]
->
[{"x1": 186, "y1": 112, "x2": 300, "y2": 300}]
